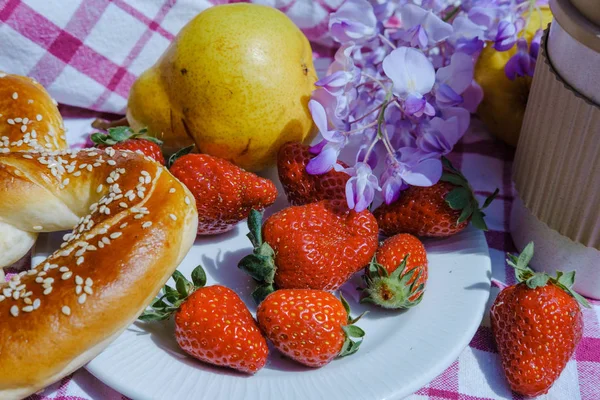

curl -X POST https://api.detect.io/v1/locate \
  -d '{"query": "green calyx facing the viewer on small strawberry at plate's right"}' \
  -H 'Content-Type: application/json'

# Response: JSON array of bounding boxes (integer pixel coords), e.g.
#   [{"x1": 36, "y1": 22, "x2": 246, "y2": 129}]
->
[{"x1": 360, "y1": 254, "x2": 425, "y2": 309}]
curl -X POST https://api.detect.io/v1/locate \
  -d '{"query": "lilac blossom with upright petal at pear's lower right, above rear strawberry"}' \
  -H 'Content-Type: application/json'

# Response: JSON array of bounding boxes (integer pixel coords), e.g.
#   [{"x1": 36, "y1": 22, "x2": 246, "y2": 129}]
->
[{"x1": 306, "y1": 100, "x2": 348, "y2": 175}]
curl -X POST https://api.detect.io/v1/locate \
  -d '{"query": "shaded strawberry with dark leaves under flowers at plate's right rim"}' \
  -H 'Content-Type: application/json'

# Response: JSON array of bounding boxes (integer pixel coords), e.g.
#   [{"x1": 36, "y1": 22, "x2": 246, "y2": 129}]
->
[{"x1": 373, "y1": 158, "x2": 498, "y2": 237}]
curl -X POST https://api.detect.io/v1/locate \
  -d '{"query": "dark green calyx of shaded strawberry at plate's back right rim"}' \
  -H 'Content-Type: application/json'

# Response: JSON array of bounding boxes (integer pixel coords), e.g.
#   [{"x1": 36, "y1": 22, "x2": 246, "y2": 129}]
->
[{"x1": 440, "y1": 157, "x2": 499, "y2": 231}]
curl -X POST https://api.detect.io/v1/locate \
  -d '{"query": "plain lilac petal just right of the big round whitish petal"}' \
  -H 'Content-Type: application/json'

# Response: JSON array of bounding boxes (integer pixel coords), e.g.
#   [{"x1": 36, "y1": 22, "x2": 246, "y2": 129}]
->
[{"x1": 435, "y1": 53, "x2": 473, "y2": 107}]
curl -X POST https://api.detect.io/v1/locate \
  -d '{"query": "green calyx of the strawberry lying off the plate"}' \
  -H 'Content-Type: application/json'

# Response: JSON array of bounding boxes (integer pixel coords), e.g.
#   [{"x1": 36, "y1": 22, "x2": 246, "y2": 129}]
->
[{"x1": 506, "y1": 242, "x2": 591, "y2": 308}]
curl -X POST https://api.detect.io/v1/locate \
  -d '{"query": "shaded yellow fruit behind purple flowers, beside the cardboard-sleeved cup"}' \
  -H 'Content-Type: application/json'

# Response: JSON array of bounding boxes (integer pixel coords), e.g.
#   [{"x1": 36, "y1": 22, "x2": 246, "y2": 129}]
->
[{"x1": 474, "y1": 7, "x2": 552, "y2": 146}]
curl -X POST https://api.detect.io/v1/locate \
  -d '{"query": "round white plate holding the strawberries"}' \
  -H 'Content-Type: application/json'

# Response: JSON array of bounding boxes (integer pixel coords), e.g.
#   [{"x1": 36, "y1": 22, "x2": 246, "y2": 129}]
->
[{"x1": 34, "y1": 177, "x2": 491, "y2": 400}]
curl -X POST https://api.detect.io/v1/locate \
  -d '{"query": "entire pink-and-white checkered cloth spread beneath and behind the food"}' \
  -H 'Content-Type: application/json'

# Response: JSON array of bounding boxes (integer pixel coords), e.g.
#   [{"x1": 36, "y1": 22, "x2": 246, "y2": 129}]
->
[{"x1": 0, "y1": 0, "x2": 600, "y2": 400}]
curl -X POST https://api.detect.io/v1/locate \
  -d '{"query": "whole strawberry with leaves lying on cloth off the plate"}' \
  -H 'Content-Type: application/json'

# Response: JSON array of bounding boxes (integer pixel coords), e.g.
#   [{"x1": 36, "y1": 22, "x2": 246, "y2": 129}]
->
[{"x1": 490, "y1": 243, "x2": 589, "y2": 396}]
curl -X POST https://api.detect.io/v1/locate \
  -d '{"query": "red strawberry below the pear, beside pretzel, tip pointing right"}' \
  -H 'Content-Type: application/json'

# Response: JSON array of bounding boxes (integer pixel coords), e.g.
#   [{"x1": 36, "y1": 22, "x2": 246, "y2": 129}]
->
[{"x1": 169, "y1": 154, "x2": 277, "y2": 235}]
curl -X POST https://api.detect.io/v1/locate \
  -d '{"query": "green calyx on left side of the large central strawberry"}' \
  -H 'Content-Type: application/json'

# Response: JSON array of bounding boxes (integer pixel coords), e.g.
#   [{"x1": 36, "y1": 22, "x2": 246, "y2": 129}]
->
[{"x1": 238, "y1": 209, "x2": 277, "y2": 304}]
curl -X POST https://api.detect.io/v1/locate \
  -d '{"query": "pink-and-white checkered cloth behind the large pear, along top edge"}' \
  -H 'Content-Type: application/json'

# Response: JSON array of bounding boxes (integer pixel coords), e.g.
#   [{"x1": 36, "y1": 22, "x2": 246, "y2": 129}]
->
[{"x1": 0, "y1": 0, "x2": 343, "y2": 113}]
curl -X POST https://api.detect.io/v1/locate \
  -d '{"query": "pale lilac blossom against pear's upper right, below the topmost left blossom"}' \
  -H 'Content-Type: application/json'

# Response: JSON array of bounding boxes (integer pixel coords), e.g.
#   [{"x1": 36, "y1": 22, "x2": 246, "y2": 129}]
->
[{"x1": 315, "y1": 43, "x2": 360, "y2": 96}]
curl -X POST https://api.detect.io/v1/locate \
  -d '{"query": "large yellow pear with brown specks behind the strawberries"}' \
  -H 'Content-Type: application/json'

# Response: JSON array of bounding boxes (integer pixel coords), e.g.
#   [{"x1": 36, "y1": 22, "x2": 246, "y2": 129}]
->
[{"x1": 127, "y1": 3, "x2": 317, "y2": 170}]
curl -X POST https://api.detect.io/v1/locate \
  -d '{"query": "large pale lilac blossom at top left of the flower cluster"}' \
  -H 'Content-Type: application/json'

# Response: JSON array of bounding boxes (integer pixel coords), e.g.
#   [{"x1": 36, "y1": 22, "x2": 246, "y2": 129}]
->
[{"x1": 329, "y1": 0, "x2": 377, "y2": 43}]
